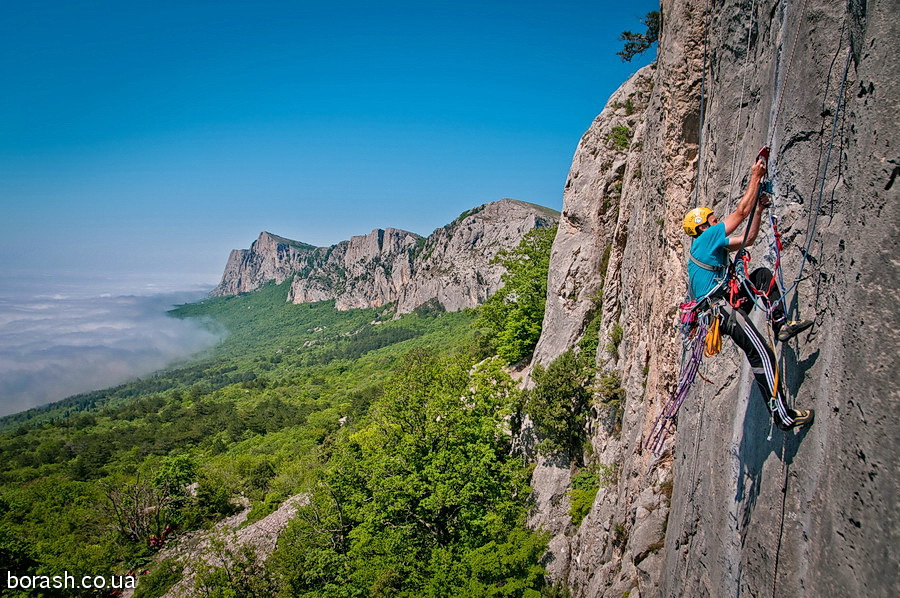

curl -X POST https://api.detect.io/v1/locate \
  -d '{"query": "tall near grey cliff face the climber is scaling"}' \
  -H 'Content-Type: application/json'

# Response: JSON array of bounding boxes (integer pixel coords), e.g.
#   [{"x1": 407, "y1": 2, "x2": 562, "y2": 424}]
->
[{"x1": 531, "y1": 0, "x2": 900, "y2": 598}]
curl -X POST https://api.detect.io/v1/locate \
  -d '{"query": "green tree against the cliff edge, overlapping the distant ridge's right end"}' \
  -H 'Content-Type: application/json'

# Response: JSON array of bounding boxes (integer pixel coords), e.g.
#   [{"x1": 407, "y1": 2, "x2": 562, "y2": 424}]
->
[{"x1": 476, "y1": 227, "x2": 556, "y2": 364}]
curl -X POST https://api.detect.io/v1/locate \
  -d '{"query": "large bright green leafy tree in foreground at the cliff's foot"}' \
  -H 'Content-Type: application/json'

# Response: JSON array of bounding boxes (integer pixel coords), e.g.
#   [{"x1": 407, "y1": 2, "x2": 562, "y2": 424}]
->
[{"x1": 274, "y1": 351, "x2": 546, "y2": 596}]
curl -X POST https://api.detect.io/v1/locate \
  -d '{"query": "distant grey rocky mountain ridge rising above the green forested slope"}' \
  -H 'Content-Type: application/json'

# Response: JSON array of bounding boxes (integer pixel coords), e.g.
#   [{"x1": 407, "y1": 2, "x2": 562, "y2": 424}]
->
[{"x1": 212, "y1": 199, "x2": 559, "y2": 314}]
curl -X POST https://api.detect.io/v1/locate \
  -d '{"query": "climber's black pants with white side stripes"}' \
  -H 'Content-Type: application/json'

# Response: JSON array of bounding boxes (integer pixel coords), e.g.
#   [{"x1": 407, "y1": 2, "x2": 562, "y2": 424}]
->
[{"x1": 721, "y1": 268, "x2": 794, "y2": 428}]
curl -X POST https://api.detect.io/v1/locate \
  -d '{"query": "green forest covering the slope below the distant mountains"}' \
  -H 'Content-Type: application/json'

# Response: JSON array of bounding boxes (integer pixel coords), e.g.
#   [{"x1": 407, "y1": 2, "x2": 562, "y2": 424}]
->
[{"x1": 0, "y1": 229, "x2": 612, "y2": 597}]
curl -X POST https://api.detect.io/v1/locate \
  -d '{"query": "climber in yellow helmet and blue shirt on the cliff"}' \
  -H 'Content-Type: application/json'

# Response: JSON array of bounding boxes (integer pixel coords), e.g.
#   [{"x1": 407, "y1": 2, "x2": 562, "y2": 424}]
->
[{"x1": 684, "y1": 157, "x2": 815, "y2": 430}]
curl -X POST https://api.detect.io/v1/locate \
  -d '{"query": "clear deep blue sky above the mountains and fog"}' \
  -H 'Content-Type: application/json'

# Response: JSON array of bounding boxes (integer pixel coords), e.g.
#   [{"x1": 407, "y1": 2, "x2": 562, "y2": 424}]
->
[{"x1": 0, "y1": 0, "x2": 658, "y2": 284}]
